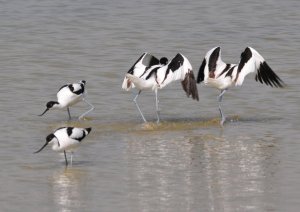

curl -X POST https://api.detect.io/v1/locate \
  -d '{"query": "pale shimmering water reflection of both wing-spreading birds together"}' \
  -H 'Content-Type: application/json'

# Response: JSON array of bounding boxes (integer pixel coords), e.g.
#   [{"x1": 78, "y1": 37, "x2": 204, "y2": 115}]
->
[{"x1": 123, "y1": 129, "x2": 276, "y2": 211}]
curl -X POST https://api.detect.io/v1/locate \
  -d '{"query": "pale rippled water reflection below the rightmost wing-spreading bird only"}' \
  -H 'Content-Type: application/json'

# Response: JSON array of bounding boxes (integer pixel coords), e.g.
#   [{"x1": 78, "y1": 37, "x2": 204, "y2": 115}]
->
[{"x1": 191, "y1": 132, "x2": 276, "y2": 211}]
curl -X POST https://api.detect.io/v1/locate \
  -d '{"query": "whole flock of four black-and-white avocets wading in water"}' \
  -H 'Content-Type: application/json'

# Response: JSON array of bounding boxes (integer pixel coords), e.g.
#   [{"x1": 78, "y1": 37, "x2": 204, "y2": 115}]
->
[{"x1": 34, "y1": 47, "x2": 285, "y2": 166}]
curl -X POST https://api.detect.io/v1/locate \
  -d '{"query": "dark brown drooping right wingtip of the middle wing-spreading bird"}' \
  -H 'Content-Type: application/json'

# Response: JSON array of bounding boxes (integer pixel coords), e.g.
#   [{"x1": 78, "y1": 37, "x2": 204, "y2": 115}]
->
[{"x1": 181, "y1": 70, "x2": 199, "y2": 101}]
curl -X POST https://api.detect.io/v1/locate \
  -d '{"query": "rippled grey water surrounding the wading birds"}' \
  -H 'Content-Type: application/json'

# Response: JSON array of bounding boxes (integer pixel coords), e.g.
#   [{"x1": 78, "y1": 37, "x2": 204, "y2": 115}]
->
[{"x1": 0, "y1": 0, "x2": 300, "y2": 212}]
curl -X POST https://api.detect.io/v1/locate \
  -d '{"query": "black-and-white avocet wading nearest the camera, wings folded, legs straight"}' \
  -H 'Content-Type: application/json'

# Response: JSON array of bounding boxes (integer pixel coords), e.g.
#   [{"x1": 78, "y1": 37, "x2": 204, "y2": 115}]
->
[{"x1": 34, "y1": 127, "x2": 92, "y2": 166}]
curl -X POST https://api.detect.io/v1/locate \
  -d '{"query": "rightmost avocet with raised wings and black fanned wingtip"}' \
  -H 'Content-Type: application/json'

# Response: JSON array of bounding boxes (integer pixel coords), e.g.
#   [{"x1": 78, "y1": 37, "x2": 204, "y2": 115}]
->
[{"x1": 197, "y1": 47, "x2": 284, "y2": 125}]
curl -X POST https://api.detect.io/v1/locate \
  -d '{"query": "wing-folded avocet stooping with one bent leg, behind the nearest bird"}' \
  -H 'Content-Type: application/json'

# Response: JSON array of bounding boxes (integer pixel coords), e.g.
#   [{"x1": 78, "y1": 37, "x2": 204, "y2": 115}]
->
[{"x1": 39, "y1": 80, "x2": 94, "y2": 120}]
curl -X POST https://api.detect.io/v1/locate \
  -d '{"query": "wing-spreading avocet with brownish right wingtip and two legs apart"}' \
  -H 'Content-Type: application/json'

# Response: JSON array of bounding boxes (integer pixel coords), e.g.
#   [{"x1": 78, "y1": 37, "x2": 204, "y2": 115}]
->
[{"x1": 122, "y1": 52, "x2": 199, "y2": 123}]
